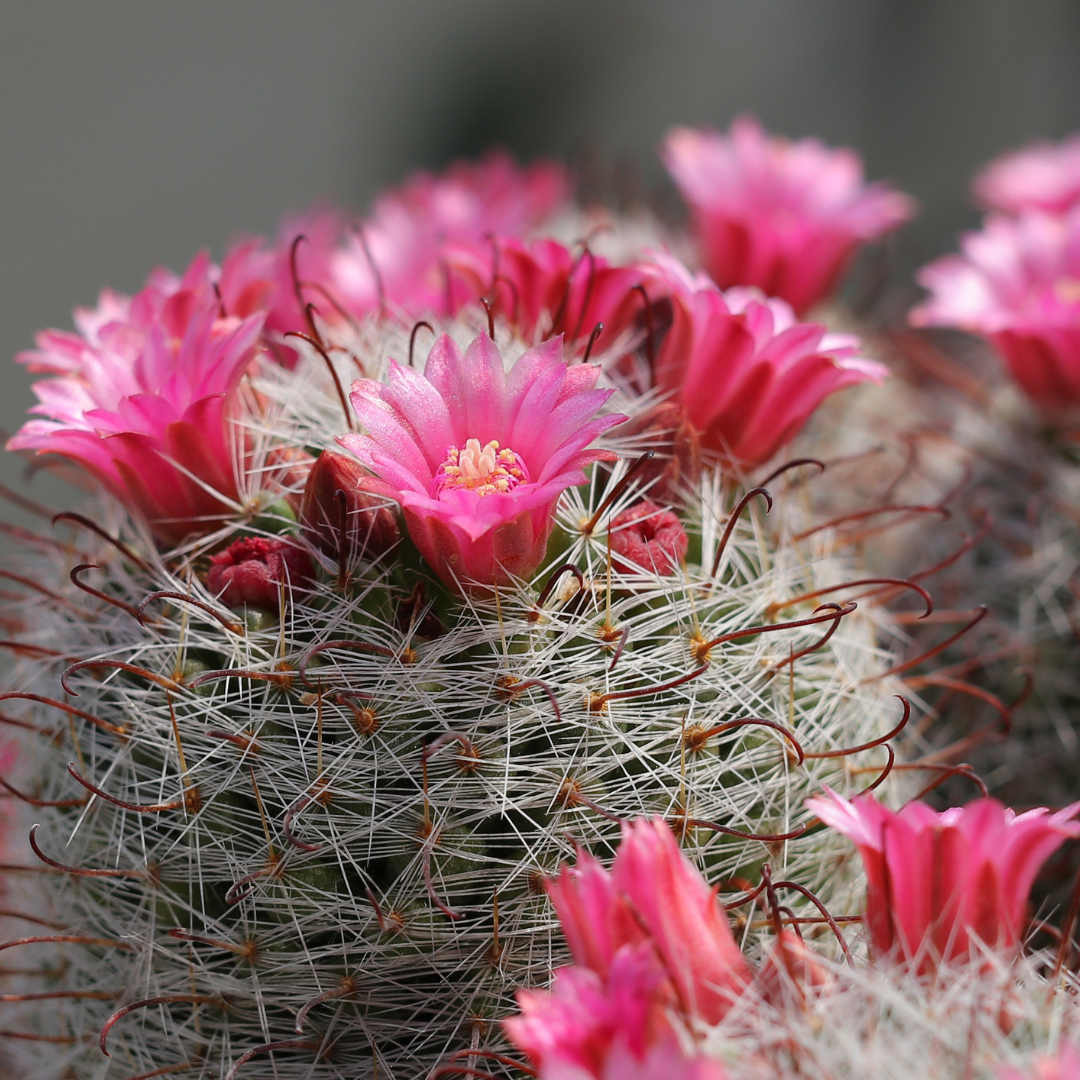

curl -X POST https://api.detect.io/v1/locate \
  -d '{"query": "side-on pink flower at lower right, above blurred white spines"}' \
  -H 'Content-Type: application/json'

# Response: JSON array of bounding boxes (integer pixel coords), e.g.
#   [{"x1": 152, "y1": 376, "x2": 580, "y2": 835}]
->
[{"x1": 807, "y1": 788, "x2": 1080, "y2": 971}]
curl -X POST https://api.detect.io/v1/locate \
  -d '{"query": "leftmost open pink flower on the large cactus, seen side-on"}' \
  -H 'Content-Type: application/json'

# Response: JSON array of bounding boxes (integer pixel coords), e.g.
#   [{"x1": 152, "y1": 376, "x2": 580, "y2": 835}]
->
[{"x1": 8, "y1": 255, "x2": 262, "y2": 543}]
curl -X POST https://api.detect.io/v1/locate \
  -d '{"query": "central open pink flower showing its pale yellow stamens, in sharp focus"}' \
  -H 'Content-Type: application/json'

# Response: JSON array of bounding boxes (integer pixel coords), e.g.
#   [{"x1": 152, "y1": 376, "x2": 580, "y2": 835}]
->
[{"x1": 338, "y1": 334, "x2": 625, "y2": 588}]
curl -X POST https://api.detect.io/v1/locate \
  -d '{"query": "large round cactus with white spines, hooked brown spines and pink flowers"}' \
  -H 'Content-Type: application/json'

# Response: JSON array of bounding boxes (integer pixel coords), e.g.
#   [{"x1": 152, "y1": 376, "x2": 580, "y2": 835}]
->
[{"x1": 2, "y1": 137, "x2": 922, "y2": 1078}]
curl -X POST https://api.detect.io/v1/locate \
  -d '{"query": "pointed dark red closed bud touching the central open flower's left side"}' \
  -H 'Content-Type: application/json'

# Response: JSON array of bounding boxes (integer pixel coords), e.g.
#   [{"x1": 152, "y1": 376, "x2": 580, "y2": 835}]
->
[{"x1": 300, "y1": 450, "x2": 401, "y2": 564}]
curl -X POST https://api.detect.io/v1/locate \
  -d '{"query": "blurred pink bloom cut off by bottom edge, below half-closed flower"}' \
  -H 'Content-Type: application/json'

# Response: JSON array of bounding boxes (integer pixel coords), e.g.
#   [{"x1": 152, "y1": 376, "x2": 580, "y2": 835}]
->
[{"x1": 503, "y1": 945, "x2": 724, "y2": 1080}]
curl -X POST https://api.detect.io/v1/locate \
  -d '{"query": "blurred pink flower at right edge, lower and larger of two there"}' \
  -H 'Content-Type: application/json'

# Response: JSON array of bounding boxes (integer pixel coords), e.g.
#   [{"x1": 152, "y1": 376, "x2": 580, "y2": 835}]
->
[{"x1": 910, "y1": 206, "x2": 1080, "y2": 419}]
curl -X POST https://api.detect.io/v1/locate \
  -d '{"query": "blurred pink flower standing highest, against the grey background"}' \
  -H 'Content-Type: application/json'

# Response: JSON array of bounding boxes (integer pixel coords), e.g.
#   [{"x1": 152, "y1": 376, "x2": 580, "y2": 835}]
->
[{"x1": 661, "y1": 117, "x2": 915, "y2": 314}]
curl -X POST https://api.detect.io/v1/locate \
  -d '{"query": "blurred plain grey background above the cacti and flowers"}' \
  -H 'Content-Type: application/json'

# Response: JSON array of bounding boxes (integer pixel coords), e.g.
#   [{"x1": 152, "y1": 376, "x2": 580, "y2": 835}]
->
[{"x1": 0, "y1": 0, "x2": 1080, "y2": 516}]
